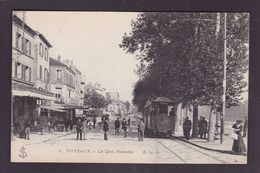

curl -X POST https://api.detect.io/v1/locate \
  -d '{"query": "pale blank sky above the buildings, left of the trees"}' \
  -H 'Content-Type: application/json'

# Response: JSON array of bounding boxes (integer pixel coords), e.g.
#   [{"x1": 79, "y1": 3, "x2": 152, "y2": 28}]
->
[{"x1": 17, "y1": 11, "x2": 138, "y2": 102}]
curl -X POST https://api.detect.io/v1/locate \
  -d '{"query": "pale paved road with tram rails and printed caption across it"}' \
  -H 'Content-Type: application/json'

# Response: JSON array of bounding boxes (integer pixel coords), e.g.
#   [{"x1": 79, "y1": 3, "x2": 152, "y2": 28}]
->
[{"x1": 12, "y1": 130, "x2": 246, "y2": 164}]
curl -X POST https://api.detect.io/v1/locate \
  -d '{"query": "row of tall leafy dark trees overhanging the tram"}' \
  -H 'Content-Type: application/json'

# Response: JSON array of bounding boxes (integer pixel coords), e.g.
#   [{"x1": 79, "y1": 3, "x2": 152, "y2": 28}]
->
[{"x1": 120, "y1": 12, "x2": 249, "y2": 140}]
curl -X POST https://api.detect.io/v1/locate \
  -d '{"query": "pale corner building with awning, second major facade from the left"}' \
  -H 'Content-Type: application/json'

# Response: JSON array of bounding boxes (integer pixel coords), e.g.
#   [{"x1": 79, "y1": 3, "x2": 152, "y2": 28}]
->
[{"x1": 46, "y1": 56, "x2": 83, "y2": 120}]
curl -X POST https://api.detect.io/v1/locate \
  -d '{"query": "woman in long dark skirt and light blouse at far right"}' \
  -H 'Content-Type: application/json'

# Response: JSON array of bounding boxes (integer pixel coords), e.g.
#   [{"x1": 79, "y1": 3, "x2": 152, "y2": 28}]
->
[{"x1": 232, "y1": 120, "x2": 246, "y2": 153}]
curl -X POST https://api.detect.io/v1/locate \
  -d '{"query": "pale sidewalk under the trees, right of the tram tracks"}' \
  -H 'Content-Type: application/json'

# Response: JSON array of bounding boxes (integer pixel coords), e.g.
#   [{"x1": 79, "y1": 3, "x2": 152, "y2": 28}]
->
[{"x1": 173, "y1": 131, "x2": 247, "y2": 154}]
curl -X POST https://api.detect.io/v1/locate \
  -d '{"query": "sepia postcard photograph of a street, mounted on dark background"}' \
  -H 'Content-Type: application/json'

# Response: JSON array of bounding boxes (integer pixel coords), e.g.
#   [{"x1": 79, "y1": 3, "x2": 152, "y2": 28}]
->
[{"x1": 8, "y1": 10, "x2": 250, "y2": 164}]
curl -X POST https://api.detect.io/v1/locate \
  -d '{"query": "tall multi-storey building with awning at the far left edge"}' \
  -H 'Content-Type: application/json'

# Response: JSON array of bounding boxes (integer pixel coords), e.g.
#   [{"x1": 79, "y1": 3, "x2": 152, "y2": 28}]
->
[{"x1": 12, "y1": 15, "x2": 54, "y2": 134}]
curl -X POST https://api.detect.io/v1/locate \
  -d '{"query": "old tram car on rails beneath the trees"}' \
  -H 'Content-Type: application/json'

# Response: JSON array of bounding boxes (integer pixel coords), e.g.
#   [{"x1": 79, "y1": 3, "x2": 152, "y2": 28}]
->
[{"x1": 143, "y1": 97, "x2": 174, "y2": 137}]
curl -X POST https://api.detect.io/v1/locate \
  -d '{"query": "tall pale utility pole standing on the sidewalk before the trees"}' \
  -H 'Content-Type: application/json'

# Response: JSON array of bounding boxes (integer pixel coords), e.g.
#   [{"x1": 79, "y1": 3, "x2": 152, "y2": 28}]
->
[{"x1": 220, "y1": 13, "x2": 227, "y2": 144}]
